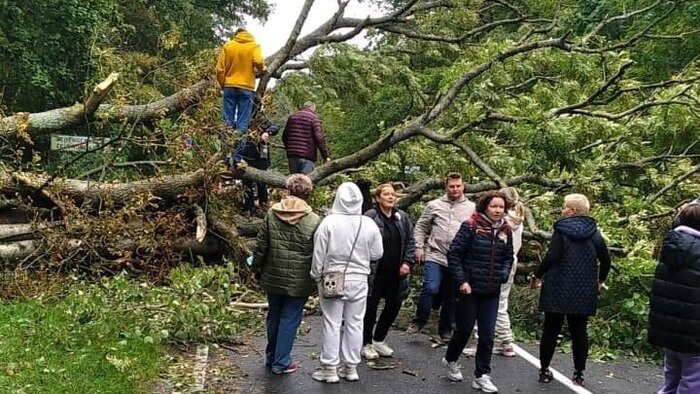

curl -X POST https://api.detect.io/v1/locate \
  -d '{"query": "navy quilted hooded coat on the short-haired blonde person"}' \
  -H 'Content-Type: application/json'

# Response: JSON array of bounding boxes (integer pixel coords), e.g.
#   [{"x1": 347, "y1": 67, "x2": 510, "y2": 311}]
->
[{"x1": 535, "y1": 216, "x2": 610, "y2": 315}]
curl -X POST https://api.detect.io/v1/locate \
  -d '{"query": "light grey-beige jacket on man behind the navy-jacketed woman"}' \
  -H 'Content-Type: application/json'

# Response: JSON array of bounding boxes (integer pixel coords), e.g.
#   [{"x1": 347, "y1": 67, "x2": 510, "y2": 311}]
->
[{"x1": 413, "y1": 195, "x2": 476, "y2": 267}]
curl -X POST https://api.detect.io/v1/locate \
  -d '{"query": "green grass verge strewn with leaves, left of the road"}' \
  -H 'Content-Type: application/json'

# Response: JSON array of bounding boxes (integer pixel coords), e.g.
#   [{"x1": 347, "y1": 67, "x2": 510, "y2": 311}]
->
[{"x1": 0, "y1": 264, "x2": 263, "y2": 394}]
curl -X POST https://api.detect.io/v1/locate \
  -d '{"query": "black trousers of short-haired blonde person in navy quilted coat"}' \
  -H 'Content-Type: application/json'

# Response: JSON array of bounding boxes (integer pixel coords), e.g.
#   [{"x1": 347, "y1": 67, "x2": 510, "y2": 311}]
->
[{"x1": 540, "y1": 312, "x2": 588, "y2": 372}]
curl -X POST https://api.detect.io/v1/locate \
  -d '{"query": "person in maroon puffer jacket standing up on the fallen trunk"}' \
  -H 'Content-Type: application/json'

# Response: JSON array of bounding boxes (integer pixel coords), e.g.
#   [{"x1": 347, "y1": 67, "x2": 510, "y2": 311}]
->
[{"x1": 282, "y1": 101, "x2": 331, "y2": 174}]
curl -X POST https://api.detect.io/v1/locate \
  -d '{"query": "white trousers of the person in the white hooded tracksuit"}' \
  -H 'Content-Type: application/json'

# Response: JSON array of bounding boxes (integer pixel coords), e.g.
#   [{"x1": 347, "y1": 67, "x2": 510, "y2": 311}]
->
[{"x1": 321, "y1": 280, "x2": 368, "y2": 366}]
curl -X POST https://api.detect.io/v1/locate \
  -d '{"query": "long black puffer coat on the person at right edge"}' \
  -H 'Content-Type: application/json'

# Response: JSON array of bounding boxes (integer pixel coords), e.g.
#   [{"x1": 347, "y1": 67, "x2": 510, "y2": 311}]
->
[{"x1": 649, "y1": 230, "x2": 700, "y2": 354}]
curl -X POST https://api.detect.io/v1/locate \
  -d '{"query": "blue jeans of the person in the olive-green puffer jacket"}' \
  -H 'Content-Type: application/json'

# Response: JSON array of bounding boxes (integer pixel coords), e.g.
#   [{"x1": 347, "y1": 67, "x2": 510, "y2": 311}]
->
[{"x1": 265, "y1": 294, "x2": 309, "y2": 372}]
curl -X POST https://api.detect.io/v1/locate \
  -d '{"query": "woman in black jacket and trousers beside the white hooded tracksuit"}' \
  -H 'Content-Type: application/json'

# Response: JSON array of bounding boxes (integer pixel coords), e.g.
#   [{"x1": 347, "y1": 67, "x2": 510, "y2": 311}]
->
[{"x1": 362, "y1": 183, "x2": 415, "y2": 360}]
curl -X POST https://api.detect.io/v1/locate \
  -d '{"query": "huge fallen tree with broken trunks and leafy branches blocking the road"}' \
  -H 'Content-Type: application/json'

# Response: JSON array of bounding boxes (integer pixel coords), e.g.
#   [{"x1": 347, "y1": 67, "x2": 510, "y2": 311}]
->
[{"x1": 0, "y1": 0, "x2": 700, "y2": 271}]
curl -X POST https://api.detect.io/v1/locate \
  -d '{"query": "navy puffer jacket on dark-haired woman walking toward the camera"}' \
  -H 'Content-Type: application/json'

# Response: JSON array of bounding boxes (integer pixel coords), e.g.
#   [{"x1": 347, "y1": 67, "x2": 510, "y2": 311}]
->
[{"x1": 447, "y1": 212, "x2": 513, "y2": 296}]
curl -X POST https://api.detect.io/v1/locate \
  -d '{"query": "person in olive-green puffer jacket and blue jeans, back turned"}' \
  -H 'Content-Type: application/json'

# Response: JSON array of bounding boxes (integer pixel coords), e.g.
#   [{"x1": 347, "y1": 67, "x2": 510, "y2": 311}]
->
[{"x1": 252, "y1": 174, "x2": 321, "y2": 374}]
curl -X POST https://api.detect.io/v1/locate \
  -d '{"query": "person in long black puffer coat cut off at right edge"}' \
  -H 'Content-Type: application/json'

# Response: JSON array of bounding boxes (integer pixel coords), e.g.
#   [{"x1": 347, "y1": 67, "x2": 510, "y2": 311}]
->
[{"x1": 648, "y1": 201, "x2": 700, "y2": 394}]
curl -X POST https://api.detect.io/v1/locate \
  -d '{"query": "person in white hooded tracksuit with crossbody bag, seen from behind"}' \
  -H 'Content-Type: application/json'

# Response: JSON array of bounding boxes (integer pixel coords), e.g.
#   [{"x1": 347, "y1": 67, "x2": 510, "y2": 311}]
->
[{"x1": 311, "y1": 182, "x2": 384, "y2": 383}]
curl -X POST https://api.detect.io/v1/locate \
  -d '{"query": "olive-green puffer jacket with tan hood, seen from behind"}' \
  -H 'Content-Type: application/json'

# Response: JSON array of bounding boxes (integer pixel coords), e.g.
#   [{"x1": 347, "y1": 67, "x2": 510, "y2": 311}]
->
[{"x1": 253, "y1": 197, "x2": 321, "y2": 297}]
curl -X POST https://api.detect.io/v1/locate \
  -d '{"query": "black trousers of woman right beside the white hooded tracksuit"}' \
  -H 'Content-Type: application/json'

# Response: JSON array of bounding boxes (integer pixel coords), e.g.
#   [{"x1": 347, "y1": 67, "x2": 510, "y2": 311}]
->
[{"x1": 362, "y1": 275, "x2": 402, "y2": 345}]
